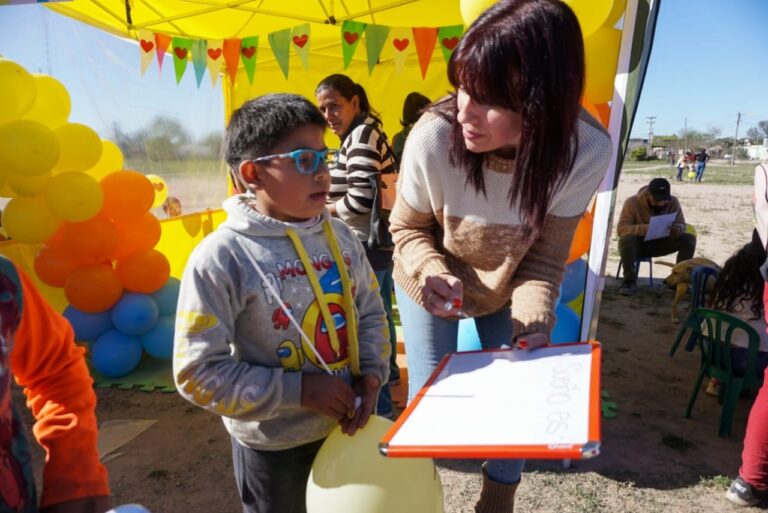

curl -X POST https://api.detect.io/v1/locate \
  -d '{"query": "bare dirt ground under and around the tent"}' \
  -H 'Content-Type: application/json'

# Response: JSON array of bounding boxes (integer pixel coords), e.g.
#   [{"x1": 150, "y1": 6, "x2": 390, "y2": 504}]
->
[{"x1": 12, "y1": 167, "x2": 752, "y2": 513}]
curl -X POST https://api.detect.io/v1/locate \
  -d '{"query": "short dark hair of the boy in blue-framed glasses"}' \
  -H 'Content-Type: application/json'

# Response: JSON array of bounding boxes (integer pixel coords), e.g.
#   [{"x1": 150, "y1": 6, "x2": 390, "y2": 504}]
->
[{"x1": 224, "y1": 93, "x2": 328, "y2": 169}]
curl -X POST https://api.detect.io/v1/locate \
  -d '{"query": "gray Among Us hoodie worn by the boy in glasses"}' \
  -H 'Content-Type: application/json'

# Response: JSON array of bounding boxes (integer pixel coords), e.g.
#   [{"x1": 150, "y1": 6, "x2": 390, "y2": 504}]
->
[{"x1": 173, "y1": 196, "x2": 390, "y2": 450}]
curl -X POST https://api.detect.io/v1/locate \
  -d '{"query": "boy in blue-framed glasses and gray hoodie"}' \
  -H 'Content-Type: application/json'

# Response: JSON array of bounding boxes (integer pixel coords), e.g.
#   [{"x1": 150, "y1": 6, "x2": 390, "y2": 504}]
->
[{"x1": 173, "y1": 94, "x2": 390, "y2": 513}]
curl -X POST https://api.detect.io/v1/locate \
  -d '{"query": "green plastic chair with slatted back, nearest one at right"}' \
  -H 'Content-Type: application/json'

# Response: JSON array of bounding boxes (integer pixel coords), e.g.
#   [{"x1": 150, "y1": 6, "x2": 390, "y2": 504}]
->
[{"x1": 685, "y1": 308, "x2": 763, "y2": 436}]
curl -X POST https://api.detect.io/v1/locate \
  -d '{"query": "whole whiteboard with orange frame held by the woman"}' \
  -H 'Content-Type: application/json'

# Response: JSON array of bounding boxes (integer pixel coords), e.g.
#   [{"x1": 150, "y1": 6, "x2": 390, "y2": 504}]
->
[{"x1": 379, "y1": 341, "x2": 600, "y2": 459}]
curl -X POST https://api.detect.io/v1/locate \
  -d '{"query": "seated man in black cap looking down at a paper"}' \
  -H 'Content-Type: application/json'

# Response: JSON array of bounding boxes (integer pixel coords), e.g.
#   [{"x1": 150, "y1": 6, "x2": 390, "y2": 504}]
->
[{"x1": 617, "y1": 178, "x2": 696, "y2": 296}]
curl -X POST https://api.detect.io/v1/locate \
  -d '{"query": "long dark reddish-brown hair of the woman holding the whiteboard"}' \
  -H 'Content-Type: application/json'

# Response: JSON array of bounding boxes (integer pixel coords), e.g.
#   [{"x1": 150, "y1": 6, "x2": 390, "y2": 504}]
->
[{"x1": 433, "y1": 0, "x2": 584, "y2": 239}]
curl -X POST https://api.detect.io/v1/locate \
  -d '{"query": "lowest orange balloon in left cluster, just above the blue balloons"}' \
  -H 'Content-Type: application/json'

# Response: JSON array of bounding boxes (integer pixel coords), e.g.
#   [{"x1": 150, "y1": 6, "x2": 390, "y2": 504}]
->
[{"x1": 64, "y1": 264, "x2": 123, "y2": 313}]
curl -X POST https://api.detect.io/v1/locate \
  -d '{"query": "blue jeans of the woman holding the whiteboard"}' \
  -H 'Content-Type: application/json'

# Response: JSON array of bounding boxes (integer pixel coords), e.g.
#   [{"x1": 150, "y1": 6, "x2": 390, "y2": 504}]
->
[{"x1": 395, "y1": 286, "x2": 525, "y2": 484}]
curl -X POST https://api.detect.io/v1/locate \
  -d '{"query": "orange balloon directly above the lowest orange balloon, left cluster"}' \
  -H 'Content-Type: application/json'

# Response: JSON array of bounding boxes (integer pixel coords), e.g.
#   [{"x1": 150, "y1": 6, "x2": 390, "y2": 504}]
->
[{"x1": 60, "y1": 215, "x2": 117, "y2": 264}]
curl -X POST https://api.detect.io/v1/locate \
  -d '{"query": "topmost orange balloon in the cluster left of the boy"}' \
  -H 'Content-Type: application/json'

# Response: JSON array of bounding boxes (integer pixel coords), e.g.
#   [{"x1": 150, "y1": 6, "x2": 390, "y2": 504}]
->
[{"x1": 100, "y1": 170, "x2": 155, "y2": 219}]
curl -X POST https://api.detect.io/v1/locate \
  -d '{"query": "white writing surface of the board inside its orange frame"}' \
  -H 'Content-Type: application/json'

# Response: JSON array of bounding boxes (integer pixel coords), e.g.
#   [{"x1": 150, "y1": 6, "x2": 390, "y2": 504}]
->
[{"x1": 389, "y1": 344, "x2": 592, "y2": 447}]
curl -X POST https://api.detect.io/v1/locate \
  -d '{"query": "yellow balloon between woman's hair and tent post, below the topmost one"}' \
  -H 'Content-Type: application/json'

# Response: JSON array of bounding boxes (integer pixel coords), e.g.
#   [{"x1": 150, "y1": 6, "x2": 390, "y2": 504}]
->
[{"x1": 584, "y1": 27, "x2": 621, "y2": 104}]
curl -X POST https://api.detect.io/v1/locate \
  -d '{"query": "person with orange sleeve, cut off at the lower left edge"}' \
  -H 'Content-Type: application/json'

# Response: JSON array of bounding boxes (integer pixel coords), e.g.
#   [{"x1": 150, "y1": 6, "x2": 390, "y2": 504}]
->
[{"x1": 0, "y1": 257, "x2": 111, "y2": 513}]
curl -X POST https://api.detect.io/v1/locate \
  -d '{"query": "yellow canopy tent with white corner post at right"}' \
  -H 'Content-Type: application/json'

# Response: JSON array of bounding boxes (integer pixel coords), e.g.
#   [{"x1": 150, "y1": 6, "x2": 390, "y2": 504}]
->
[{"x1": 19, "y1": 0, "x2": 659, "y2": 340}]
